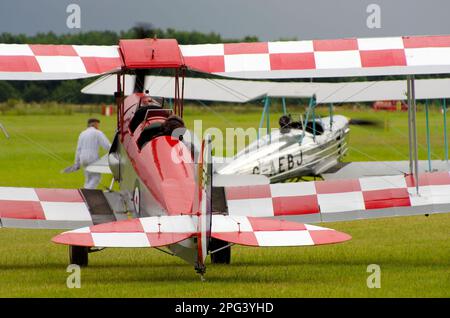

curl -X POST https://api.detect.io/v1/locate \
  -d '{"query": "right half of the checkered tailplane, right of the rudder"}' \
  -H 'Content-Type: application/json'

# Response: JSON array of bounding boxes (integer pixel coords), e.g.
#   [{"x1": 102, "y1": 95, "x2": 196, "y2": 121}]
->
[{"x1": 212, "y1": 215, "x2": 351, "y2": 246}]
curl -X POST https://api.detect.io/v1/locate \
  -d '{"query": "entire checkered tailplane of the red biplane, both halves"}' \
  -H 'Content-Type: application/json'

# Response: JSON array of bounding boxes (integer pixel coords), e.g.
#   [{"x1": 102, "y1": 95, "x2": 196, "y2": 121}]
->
[{"x1": 53, "y1": 215, "x2": 351, "y2": 247}]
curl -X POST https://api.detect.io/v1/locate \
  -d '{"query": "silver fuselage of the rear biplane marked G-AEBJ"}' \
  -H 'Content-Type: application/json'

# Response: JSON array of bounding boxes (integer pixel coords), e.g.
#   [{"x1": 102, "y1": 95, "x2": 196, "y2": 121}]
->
[{"x1": 216, "y1": 115, "x2": 350, "y2": 182}]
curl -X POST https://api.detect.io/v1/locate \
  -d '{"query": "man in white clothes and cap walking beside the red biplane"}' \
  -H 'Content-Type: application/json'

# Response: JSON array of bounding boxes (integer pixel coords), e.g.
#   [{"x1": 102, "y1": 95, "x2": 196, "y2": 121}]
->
[{"x1": 75, "y1": 118, "x2": 111, "y2": 189}]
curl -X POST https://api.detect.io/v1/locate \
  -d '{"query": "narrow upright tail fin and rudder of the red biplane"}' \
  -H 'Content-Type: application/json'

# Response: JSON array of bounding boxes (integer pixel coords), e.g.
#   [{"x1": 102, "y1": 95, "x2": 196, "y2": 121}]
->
[{"x1": 196, "y1": 135, "x2": 213, "y2": 274}]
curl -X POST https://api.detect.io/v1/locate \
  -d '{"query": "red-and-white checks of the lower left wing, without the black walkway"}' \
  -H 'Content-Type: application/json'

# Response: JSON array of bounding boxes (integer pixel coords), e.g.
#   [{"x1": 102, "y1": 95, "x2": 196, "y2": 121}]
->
[{"x1": 0, "y1": 187, "x2": 92, "y2": 224}]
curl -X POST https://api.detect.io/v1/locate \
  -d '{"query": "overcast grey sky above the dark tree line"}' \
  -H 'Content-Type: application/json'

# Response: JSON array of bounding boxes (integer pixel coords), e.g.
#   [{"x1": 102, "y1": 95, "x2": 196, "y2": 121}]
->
[{"x1": 0, "y1": 0, "x2": 450, "y2": 40}]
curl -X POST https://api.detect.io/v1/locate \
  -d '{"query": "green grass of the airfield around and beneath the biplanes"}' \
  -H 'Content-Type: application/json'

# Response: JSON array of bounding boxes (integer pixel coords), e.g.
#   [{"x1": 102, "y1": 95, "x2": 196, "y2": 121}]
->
[{"x1": 0, "y1": 107, "x2": 450, "y2": 297}]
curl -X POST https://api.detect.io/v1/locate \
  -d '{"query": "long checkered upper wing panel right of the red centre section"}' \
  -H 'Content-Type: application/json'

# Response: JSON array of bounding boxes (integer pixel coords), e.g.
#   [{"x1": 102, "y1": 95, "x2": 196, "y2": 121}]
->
[{"x1": 180, "y1": 36, "x2": 450, "y2": 78}]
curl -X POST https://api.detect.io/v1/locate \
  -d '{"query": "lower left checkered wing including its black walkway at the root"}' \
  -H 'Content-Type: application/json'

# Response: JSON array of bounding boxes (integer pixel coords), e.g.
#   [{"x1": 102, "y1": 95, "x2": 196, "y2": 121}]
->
[{"x1": 0, "y1": 187, "x2": 123, "y2": 229}]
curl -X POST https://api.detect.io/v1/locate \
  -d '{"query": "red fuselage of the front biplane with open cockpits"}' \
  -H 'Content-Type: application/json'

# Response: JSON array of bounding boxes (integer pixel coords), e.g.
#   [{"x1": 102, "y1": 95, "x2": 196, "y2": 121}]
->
[{"x1": 119, "y1": 93, "x2": 196, "y2": 215}]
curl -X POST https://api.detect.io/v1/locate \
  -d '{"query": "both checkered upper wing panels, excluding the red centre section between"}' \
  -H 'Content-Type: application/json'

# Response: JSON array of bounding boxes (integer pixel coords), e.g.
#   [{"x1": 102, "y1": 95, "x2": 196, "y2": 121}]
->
[{"x1": 0, "y1": 36, "x2": 450, "y2": 80}]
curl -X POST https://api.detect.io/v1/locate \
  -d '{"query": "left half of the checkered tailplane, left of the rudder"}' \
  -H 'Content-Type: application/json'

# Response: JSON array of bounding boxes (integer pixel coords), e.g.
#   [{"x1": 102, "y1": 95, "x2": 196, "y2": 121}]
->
[{"x1": 52, "y1": 215, "x2": 197, "y2": 247}]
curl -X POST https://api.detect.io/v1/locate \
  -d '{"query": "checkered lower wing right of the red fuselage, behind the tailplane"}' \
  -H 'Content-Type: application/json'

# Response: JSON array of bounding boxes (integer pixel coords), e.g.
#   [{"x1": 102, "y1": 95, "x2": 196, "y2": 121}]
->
[{"x1": 220, "y1": 172, "x2": 450, "y2": 222}]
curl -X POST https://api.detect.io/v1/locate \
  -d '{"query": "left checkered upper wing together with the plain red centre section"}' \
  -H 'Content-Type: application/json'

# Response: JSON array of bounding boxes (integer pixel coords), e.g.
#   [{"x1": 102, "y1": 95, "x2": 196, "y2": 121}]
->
[{"x1": 0, "y1": 39, "x2": 183, "y2": 80}]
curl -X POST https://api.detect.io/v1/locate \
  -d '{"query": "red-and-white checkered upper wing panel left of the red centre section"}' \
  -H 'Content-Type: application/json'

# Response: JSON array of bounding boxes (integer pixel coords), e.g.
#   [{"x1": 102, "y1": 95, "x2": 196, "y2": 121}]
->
[{"x1": 0, "y1": 44, "x2": 122, "y2": 80}]
